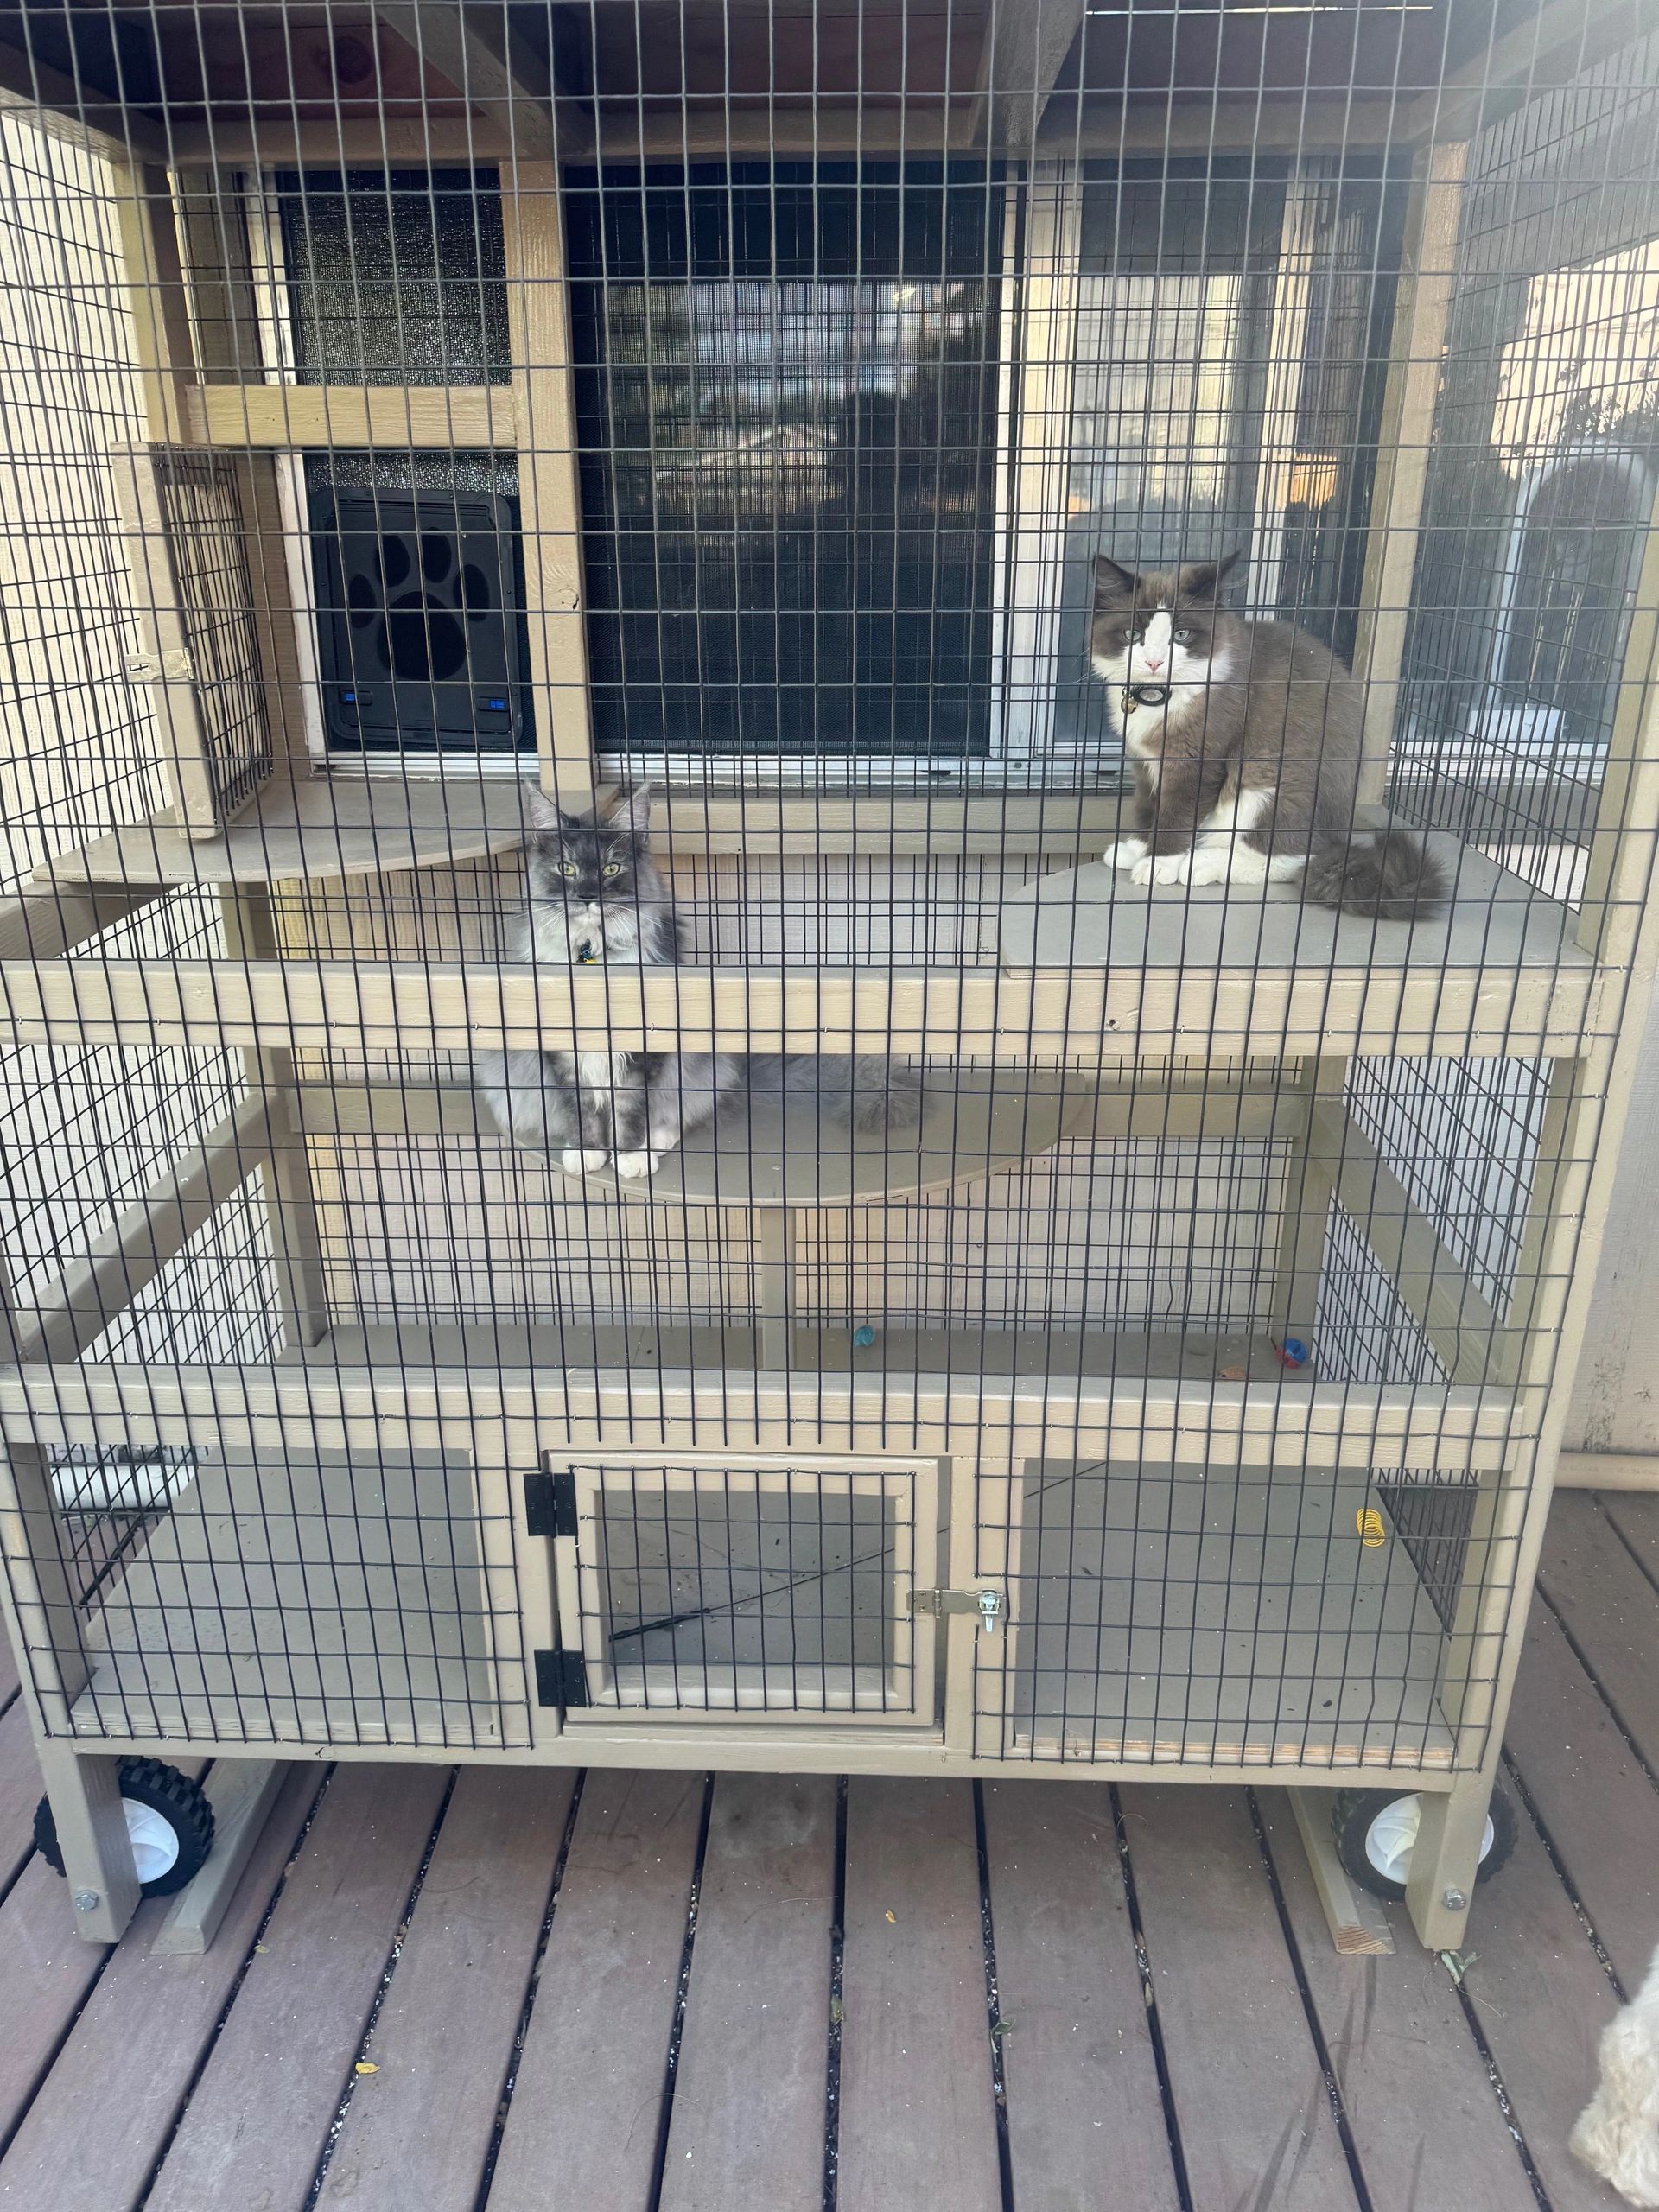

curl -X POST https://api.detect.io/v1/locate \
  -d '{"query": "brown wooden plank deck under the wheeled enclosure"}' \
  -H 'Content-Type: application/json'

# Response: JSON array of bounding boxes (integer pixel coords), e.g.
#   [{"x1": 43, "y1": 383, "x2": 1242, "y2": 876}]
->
[{"x1": 0, "y1": 1496, "x2": 1659, "y2": 2212}]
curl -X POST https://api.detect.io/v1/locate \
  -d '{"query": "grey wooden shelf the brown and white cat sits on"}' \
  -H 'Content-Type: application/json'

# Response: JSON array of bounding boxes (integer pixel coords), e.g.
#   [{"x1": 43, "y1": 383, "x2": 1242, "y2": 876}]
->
[{"x1": 980, "y1": 807, "x2": 1595, "y2": 973}]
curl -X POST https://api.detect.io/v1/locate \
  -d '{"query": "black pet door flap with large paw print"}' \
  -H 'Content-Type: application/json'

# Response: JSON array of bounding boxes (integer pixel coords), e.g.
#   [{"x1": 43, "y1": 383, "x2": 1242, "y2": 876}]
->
[{"x1": 309, "y1": 489, "x2": 529, "y2": 752}]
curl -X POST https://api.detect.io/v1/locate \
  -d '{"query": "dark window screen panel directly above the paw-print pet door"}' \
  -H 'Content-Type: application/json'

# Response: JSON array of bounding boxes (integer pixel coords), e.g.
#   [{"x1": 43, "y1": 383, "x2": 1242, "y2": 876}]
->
[{"x1": 274, "y1": 168, "x2": 511, "y2": 385}]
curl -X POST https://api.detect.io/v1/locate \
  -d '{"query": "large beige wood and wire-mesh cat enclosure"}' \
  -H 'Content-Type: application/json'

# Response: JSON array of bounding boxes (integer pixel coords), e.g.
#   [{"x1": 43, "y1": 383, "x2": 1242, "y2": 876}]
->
[{"x1": 0, "y1": 0, "x2": 1659, "y2": 1944}]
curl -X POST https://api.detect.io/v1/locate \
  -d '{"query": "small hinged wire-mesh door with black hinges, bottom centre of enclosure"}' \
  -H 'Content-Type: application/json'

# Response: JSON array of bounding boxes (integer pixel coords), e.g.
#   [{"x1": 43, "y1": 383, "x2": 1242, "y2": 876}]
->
[{"x1": 526, "y1": 1453, "x2": 940, "y2": 1727}]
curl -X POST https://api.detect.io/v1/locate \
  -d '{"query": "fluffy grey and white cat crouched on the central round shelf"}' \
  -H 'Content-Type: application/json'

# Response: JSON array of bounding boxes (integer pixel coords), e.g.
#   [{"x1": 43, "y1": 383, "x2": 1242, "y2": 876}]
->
[{"x1": 475, "y1": 790, "x2": 920, "y2": 1177}]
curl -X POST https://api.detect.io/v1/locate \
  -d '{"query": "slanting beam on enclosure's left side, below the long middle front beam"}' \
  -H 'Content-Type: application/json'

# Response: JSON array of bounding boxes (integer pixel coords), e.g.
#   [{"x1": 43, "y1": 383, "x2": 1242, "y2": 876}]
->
[{"x1": 11, "y1": 1097, "x2": 270, "y2": 1367}]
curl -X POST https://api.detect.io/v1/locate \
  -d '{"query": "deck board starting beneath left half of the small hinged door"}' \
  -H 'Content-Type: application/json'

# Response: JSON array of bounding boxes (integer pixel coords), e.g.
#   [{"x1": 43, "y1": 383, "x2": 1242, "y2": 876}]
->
[{"x1": 486, "y1": 1774, "x2": 706, "y2": 2212}]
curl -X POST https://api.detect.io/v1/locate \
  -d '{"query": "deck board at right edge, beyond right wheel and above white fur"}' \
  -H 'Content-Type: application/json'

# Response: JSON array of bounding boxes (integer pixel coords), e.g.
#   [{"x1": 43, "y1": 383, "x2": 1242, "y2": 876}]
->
[{"x1": 1509, "y1": 1606, "x2": 1659, "y2": 1991}]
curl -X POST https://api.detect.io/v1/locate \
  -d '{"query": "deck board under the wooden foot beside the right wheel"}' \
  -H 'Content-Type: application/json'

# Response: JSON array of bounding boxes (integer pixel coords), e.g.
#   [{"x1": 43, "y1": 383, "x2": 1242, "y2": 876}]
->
[{"x1": 1259, "y1": 1789, "x2": 1537, "y2": 2212}]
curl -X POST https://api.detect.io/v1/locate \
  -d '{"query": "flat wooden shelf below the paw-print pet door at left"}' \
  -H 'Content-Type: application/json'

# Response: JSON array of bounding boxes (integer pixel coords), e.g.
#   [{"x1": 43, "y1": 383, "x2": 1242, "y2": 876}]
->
[{"x1": 38, "y1": 777, "x2": 526, "y2": 885}]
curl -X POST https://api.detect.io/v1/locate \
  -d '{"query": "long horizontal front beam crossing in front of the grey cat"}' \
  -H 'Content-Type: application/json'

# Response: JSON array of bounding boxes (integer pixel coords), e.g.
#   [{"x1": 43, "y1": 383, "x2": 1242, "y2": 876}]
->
[{"x1": 0, "y1": 960, "x2": 1619, "y2": 1066}]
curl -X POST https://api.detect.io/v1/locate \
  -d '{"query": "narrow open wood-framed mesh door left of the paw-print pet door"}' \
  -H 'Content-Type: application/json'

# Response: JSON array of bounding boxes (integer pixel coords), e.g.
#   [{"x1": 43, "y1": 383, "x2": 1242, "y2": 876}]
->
[{"x1": 111, "y1": 445, "x2": 270, "y2": 836}]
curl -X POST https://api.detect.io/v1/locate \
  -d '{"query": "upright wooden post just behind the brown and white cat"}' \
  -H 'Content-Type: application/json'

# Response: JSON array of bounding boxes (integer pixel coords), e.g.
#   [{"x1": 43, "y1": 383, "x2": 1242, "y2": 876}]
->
[{"x1": 1354, "y1": 146, "x2": 1469, "y2": 805}]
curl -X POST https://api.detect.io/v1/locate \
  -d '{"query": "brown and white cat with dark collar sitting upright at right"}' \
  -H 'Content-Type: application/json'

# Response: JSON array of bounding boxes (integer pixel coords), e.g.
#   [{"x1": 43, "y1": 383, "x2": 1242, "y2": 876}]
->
[{"x1": 1089, "y1": 553, "x2": 1446, "y2": 923}]
